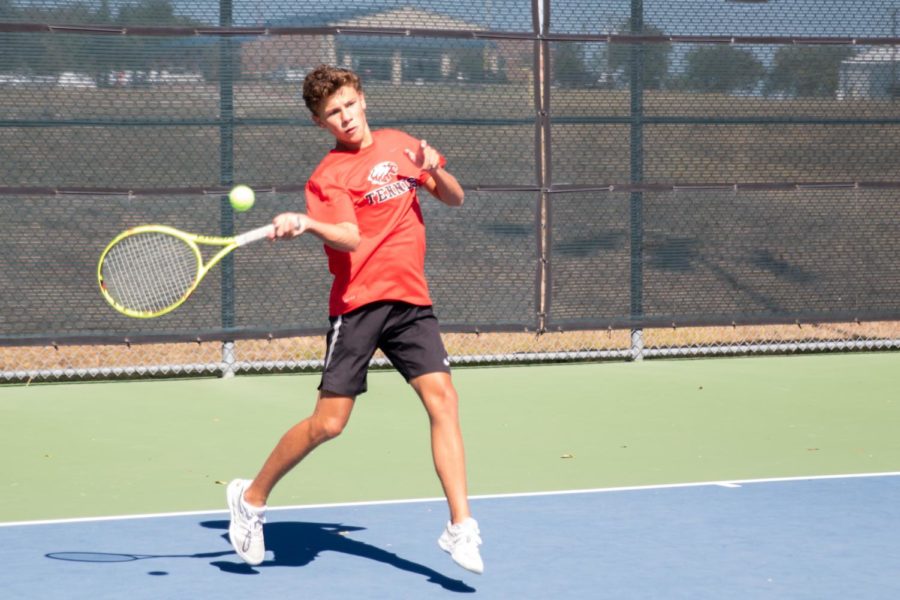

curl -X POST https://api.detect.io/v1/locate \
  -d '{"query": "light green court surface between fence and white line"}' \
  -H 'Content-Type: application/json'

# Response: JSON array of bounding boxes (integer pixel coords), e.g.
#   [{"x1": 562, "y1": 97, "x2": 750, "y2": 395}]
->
[{"x1": 0, "y1": 352, "x2": 900, "y2": 522}]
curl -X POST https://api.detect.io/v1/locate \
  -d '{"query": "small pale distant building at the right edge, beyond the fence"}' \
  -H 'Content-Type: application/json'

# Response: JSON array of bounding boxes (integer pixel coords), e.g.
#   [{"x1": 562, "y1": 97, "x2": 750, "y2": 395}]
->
[{"x1": 837, "y1": 47, "x2": 900, "y2": 100}]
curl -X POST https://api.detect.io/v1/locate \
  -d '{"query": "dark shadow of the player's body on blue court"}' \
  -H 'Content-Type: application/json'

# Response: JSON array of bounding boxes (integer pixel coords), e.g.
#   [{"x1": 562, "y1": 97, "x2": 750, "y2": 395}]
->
[{"x1": 200, "y1": 520, "x2": 475, "y2": 593}]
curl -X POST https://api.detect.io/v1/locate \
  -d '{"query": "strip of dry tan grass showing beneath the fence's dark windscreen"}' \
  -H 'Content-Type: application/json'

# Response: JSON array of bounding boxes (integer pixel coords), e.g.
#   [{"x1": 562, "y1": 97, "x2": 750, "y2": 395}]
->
[{"x1": 0, "y1": 321, "x2": 900, "y2": 379}]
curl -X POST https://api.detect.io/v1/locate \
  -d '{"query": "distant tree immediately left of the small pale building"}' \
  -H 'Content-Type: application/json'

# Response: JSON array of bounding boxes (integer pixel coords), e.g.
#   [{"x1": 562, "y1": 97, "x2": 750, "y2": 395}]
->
[{"x1": 766, "y1": 46, "x2": 853, "y2": 97}]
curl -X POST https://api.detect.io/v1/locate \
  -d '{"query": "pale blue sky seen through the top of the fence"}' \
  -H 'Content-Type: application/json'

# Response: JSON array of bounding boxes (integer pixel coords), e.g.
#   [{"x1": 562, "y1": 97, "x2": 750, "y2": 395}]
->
[{"x1": 7, "y1": 0, "x2": 900, "y2": 37}]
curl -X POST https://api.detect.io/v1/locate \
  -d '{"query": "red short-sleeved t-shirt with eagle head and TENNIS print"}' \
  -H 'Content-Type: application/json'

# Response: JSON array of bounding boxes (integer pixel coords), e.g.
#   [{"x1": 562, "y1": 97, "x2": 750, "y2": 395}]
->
[{"x1": 306, "y1": 129, "x2": 446, "y2": 316}]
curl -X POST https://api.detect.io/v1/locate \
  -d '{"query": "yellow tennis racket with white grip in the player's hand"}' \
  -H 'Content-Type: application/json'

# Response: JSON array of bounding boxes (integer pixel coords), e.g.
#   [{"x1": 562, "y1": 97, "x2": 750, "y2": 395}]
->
[{"x1": 97, "y1": 225, "x2": 274, "y2": 319}]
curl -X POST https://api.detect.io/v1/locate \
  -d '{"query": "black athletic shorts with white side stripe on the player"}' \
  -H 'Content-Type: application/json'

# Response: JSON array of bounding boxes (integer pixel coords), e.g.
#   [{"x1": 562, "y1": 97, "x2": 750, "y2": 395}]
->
[{"x1": 319, "y1": 302, "x2": 450, "y2": 396}]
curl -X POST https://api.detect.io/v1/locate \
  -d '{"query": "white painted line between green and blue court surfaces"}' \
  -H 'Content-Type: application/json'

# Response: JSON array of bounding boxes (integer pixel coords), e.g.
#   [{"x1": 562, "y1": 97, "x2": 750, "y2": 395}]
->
[{"x1": 0, "y1": 471, "x2": 900, "y2": 527}]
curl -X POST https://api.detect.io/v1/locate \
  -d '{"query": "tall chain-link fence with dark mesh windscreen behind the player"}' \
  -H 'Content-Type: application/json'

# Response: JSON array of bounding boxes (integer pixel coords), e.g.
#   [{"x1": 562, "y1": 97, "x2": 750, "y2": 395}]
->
[{"x1": 0, "y1": 0, "x2": 900, "y2": 381}]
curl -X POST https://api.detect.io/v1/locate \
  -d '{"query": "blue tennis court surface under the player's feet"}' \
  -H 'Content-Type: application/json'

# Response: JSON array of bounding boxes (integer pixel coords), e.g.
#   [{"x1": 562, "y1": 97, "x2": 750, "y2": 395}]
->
[{"x1": 0, "y1": 473, "x2": 900, "y2": 600}]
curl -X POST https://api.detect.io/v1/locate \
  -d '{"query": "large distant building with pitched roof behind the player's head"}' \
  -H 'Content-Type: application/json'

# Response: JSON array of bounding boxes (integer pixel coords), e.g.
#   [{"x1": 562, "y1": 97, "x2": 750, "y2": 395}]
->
[{"x1": 241, "y1": 7, "x2": 500, "y2": 84}]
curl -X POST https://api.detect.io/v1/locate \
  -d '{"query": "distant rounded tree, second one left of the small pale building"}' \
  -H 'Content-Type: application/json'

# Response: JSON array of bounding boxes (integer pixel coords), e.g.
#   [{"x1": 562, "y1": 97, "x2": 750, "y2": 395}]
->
[{"x1": 683, "y1": 46, "x2": 766, "y2": 94}]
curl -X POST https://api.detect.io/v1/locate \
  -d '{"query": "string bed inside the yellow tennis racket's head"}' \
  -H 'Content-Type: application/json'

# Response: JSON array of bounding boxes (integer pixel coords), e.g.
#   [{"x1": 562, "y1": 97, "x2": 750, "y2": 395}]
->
[{"x1": 101, "y1": 232, "x2": 198, "y2": 313}]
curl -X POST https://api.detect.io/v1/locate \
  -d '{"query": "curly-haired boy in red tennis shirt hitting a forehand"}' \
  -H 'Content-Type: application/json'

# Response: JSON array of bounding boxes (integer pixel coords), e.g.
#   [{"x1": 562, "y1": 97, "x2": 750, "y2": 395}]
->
[{"x1": 227, "y1": 65, "x2": 484, "y2": 573}]
